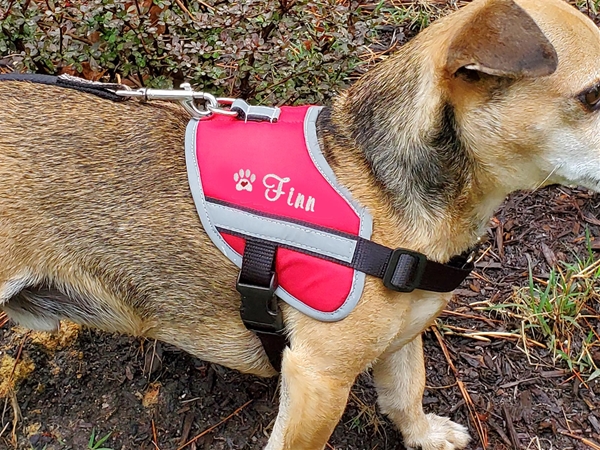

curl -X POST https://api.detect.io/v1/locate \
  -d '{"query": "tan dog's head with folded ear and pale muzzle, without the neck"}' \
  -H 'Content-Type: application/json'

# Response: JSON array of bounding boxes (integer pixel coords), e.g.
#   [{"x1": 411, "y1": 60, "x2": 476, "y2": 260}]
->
[{"x1": 442, "y1": 0, "x2": 600, "y2": 191}]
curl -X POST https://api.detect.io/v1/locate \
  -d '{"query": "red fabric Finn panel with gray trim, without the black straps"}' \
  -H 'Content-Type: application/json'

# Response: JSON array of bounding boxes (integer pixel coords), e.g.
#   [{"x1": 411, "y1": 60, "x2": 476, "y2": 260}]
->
[{"x1": 186, "y1": 107, "x2": 372, "y2": 321}]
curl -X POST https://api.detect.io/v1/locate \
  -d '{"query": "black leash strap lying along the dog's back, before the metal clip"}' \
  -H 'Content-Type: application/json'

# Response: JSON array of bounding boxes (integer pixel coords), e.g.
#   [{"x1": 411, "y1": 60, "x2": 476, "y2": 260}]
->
[{"x1": 0, "y1": 73, "x2": 127, "y2": 102}]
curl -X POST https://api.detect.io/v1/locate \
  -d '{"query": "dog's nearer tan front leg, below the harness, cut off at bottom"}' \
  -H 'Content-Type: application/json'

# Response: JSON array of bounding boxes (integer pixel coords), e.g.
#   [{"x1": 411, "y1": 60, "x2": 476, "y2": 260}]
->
[{"x1": 265, "y1": 346, "x2": 359, "y2": 450}]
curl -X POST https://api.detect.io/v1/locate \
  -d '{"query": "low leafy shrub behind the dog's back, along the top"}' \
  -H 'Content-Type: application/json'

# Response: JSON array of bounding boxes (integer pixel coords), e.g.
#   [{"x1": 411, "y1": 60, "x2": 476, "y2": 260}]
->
[{"x1": 0, "y1": 0, "x2": 448, "y2": 104}]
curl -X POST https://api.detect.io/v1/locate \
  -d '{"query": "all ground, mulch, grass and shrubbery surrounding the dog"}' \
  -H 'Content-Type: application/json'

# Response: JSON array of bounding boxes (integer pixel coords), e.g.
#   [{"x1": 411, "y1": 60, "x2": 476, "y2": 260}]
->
[{"x1": 0, "y1": 0, "x2": 600, "y2": 450}]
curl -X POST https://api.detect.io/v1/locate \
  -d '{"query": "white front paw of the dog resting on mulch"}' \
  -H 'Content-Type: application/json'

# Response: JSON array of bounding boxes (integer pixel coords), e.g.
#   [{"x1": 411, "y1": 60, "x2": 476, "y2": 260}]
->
[{"x1": 405, "y1": 414, "x2": 471, "y2": 450}]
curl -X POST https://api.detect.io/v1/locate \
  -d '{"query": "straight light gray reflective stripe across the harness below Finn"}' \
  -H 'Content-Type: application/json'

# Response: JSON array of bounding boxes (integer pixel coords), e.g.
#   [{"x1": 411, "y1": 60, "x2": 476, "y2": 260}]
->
[{"x1": 206, "y1": 202, "x2": 356, "y2": 263}]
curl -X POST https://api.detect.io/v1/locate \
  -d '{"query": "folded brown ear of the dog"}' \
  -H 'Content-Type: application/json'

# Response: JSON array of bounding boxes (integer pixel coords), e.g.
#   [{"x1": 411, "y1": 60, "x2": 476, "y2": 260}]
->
[{"x1": 446, "y1": 0, "x2": 558, "y2": 78}]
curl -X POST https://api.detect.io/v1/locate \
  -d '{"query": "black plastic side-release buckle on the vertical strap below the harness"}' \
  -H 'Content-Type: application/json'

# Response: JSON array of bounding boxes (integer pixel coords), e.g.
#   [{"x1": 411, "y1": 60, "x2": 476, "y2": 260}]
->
[{"x1": 235, "y1": 273, "x2": 283, "y2": 334}]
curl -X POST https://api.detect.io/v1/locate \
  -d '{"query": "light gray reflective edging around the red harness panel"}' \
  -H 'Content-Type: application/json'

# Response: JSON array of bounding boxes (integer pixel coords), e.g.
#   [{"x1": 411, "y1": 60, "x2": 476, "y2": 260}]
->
[{"x1": 185, "y1": 106, "x2": 372, "y2": 322}]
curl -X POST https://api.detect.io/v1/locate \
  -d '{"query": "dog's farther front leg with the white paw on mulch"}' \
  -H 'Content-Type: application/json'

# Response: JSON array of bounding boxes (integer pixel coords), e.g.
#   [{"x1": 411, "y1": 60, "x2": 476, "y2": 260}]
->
[{"x1": 373, "y1": 335, "x2": 470, "y2": 450}]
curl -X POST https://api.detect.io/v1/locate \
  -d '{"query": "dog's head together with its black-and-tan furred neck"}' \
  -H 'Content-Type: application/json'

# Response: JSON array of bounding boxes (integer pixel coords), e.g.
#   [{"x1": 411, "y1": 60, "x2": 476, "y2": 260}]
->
[{"x1": 334, "y1": 0, "x2": 600, "y2": 248}]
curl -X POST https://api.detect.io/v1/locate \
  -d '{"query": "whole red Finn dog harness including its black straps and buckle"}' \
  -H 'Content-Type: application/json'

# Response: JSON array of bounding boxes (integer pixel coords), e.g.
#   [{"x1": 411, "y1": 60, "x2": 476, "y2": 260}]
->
[{"x1": 186, "y1": 104, "x2": 470, "y2": 338}]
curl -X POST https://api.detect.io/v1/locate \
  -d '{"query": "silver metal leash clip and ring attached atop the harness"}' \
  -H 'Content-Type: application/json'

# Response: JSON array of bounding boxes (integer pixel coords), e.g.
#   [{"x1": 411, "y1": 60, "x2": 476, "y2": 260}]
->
[{"x1": 115, "y1": 83, "x2": 281, "y2": 123}]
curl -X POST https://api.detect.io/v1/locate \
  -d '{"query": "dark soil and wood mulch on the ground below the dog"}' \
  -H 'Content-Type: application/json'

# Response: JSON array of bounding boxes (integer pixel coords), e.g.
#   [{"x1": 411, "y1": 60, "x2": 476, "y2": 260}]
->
[{"x1": 0, "y1": 187, "x2": 600, "y2": 450}]
